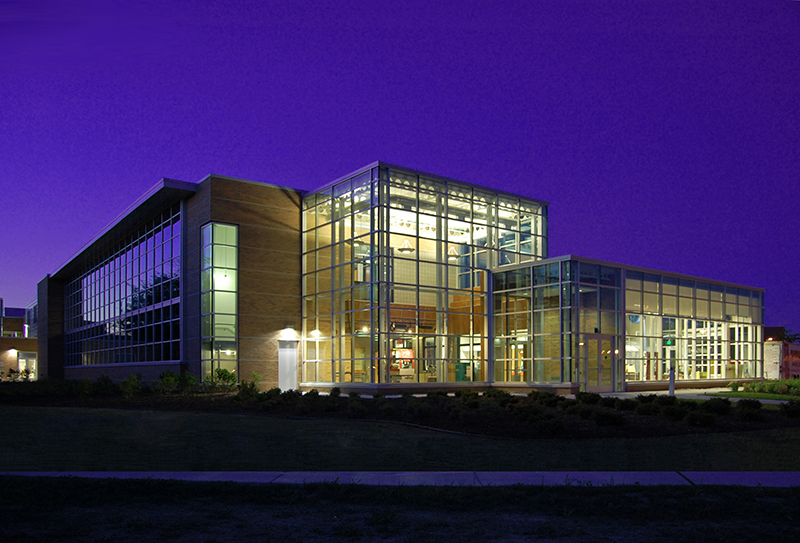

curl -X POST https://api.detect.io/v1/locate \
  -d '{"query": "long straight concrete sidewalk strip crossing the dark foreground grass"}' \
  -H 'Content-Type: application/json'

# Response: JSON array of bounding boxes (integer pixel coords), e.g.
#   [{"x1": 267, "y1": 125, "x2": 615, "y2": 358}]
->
[{"x1": 0, "y1": 471, "x2": 800, "y2": 487}]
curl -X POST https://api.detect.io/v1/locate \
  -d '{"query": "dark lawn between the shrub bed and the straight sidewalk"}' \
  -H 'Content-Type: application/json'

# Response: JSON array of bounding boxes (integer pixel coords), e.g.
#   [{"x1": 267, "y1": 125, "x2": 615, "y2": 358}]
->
[{"x1": 0, "y1": 406, "x2": 800, "y2": 471}]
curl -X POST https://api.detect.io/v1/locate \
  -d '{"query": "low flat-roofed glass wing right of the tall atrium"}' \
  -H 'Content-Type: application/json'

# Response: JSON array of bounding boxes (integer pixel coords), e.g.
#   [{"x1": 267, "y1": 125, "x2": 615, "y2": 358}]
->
[{"x1": 493, "y1": 256, "x2": 764, "y2": 391}]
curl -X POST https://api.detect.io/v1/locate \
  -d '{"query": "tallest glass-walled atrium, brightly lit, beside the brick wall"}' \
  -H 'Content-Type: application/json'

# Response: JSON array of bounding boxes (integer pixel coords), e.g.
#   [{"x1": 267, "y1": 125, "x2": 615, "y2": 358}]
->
[{"x1": 303, "y1": 168, "x2": 547, "y2": 383}]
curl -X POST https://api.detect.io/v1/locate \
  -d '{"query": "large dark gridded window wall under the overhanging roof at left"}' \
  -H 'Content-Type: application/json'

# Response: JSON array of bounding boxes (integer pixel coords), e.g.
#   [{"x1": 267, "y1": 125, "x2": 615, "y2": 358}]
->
[{"x1": 64, "y1": 204, "x2": 181, "y2": 366}]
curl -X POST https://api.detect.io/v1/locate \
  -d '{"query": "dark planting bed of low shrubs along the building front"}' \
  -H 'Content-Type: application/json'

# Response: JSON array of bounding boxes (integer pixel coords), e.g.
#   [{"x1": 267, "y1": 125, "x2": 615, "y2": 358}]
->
[{"x1": 0, "y1": 376, "x2": 800, "y2": 439}]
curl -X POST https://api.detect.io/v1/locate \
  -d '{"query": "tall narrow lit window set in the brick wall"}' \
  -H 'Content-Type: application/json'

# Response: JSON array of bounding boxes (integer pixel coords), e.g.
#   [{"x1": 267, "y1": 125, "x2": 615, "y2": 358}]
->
[{"x1": 200, "y1": 223, "x2": 239, "y2": 381}]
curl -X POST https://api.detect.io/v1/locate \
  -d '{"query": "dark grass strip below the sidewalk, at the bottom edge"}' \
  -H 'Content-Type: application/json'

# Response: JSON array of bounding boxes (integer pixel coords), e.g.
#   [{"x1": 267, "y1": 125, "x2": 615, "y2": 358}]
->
[{"x1": 0, "y1": 477, "x2": 800, "y2": 543}]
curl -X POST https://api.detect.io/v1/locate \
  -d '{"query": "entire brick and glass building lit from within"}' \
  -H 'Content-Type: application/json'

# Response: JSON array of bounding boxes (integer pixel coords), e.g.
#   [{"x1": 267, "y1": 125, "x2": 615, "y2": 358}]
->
[{"x1": 38, "y1": 162, "x2": 764, "y2": 391}]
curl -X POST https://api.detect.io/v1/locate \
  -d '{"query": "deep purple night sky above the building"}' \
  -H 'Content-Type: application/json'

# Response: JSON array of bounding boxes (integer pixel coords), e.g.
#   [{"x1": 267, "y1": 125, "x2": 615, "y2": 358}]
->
[{"x1": 0, "y1": 0, "x2": 800, "y2": 331}]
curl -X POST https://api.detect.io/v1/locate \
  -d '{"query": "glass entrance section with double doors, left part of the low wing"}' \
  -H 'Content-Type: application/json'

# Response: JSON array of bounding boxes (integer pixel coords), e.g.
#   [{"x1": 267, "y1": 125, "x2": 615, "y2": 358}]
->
[{"x1": 493, "y1": 261, "x2": 621, "y2": 387}]
